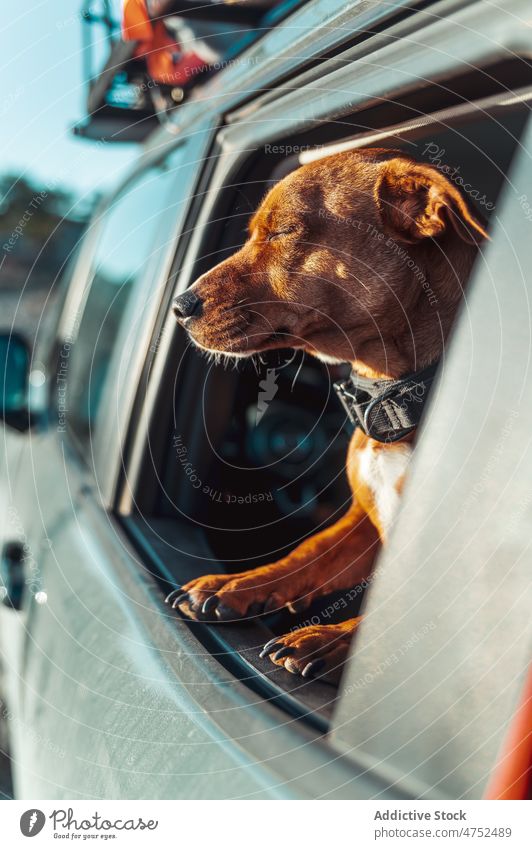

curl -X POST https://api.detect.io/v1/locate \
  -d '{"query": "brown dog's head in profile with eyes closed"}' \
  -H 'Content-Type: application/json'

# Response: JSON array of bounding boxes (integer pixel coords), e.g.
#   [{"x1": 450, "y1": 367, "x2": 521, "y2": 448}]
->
[{"x1": 173, "y1": 149, "x2": 486, "y2": 361}]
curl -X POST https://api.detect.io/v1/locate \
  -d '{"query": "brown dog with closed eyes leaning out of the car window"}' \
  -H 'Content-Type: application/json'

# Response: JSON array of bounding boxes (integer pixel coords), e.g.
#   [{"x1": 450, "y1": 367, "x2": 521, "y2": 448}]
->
[{"x1": 169, "y1": 149, "x2": 486, "y2": 680}]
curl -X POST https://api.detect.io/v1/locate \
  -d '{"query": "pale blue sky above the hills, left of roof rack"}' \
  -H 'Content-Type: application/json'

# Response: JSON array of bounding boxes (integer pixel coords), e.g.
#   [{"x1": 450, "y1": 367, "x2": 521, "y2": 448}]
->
[{"x1": 0, "y1": 0, "x2": 140, "y2": 204}]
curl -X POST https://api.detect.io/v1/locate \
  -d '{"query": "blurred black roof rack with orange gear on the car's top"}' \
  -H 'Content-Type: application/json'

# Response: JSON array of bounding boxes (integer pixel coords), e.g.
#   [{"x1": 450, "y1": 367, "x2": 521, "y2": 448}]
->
[{"x1": 74, "y1": 0, "x2": 303, "y2": 142}]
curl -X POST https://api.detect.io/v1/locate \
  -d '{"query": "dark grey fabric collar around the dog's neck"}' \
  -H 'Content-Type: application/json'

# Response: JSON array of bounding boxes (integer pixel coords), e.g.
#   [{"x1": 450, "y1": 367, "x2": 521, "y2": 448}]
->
[{"x1": 334, "y1": 362, "x2": 438, "y2": 442}]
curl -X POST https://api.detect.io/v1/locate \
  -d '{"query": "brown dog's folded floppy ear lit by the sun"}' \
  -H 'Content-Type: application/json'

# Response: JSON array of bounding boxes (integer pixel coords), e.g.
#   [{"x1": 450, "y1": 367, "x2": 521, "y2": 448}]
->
[{"x1": 375, "y1": 157, "x2": 489, "y2": 244}]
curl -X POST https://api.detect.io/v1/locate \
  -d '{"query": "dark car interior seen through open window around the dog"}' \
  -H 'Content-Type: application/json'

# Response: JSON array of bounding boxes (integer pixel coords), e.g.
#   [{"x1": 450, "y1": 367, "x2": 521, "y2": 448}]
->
[{"x1": 115, "y1": 56, "x2": 532, "y2": 729}]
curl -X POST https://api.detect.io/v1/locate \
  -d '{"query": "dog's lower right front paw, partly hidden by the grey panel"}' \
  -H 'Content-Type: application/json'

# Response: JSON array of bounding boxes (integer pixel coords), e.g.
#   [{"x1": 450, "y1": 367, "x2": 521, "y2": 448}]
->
[{"x1": 260, "y1": 616, "x2": 362, "y2": 684}]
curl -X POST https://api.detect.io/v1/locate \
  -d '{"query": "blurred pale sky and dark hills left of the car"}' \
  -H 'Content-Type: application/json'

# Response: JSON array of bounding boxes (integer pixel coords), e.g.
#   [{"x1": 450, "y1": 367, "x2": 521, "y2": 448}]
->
[{"x1": 0, "y1": 0, "x2": 138, "y2": 339}]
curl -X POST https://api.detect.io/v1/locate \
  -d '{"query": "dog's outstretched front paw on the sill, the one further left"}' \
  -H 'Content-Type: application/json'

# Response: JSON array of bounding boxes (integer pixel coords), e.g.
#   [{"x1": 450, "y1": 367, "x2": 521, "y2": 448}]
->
[{"x1": 166, "y1": 566, "x2": 311, "y2": 622}]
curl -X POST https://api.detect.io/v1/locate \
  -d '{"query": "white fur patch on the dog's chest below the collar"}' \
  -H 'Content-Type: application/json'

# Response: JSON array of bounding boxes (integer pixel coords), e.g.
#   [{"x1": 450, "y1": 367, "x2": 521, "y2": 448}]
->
[{"x1": 358, "y1": 442, "x2": 412, "y2": 538}]
